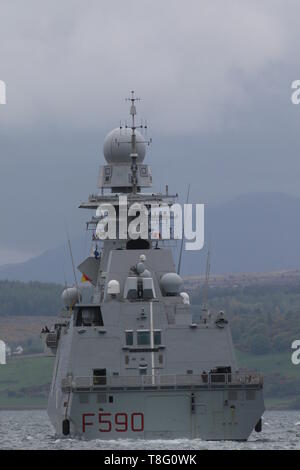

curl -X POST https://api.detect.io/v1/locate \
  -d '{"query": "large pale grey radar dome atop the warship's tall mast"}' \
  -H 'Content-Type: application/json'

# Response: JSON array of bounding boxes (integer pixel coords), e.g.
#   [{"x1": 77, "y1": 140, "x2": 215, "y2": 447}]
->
[{"x1": 103, "y1": 127, "x2": 146, "y2": 163}]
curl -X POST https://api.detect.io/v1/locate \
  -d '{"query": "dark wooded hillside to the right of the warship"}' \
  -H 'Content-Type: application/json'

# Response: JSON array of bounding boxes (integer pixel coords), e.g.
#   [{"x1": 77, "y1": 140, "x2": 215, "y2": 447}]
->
[{"x1": 192, "y1": 285, "x2": 300, "y2": 354}]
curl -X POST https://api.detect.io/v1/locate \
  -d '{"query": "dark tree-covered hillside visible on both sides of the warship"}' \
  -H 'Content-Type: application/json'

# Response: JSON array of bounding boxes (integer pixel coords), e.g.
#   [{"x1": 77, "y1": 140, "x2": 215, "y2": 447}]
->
[{"x1": 0, "y1": 281, "x2": 300, "y2": 354}]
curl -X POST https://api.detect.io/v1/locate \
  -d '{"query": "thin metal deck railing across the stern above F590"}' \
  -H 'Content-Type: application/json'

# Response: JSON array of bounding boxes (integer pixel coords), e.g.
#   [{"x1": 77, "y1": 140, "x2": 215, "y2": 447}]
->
[{"x1": 62, "y1": 372, "x2": 263, "y2": 389}]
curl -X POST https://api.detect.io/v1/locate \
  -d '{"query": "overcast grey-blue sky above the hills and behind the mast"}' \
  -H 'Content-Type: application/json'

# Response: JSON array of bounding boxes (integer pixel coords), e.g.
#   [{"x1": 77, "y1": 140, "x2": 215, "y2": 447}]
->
[{"x1": 0, "y1": 0, "x2": 300, "y2": 265}]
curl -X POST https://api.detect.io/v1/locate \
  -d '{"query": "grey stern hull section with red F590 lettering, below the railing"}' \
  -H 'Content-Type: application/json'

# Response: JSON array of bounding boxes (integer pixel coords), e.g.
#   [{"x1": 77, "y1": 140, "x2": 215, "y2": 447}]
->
[{"x1": 48, "y1": 387, "x2": 264, "y2": 441}]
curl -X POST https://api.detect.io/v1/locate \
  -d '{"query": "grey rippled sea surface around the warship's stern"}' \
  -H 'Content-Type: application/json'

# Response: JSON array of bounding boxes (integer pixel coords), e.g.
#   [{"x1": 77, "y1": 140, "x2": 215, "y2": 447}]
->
[{"x1": 0, "y1": 410, "x2": 300, "y2": 450}]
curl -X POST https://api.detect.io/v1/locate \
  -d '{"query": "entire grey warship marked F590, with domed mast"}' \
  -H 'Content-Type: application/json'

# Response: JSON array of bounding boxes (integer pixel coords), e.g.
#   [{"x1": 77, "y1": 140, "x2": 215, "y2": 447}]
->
[{"x1": 43, "y1": 92, "x2": 264, "y2": 441}]
